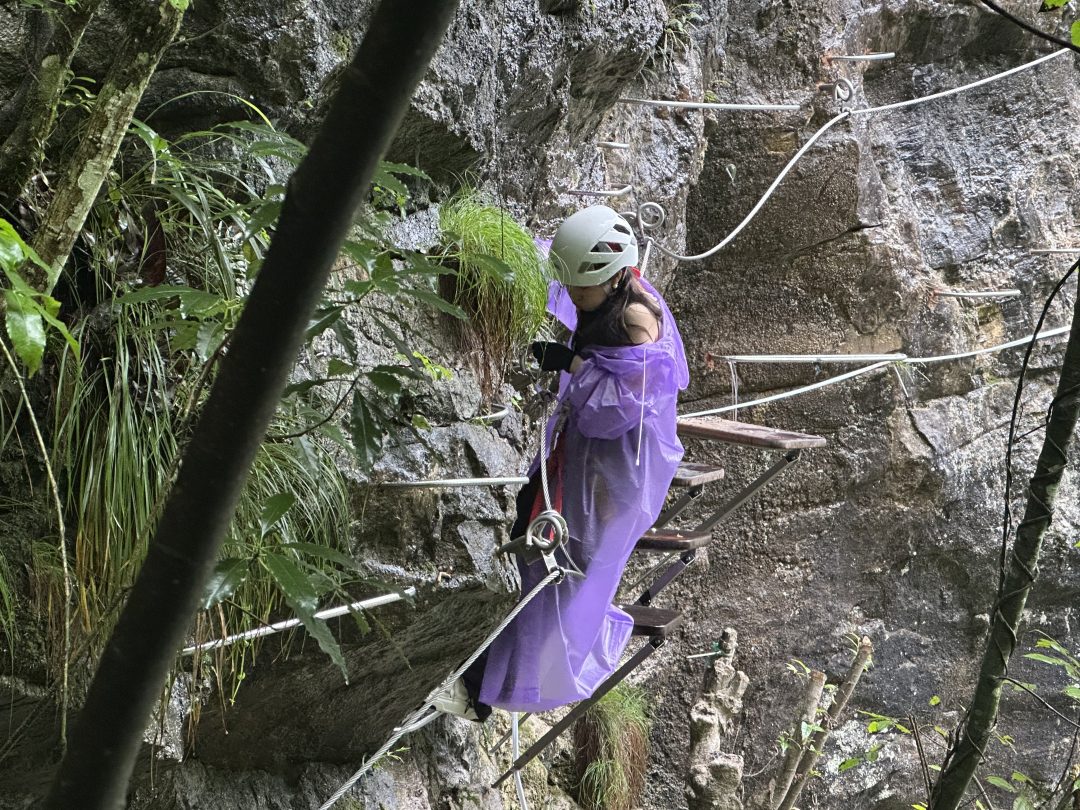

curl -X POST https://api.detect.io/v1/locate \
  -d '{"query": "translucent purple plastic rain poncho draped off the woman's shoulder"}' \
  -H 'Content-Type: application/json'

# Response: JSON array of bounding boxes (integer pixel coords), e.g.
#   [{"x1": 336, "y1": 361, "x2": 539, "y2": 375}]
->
[{"x1": 480, "y1": 279, "x2": 689, "y2": 712}]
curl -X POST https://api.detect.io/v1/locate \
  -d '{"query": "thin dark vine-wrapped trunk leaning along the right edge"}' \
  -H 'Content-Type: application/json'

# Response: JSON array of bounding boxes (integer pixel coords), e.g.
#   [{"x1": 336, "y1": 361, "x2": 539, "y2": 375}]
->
[{"x1": 930, "y1": 298, "x2": 1080, "y2": 810}]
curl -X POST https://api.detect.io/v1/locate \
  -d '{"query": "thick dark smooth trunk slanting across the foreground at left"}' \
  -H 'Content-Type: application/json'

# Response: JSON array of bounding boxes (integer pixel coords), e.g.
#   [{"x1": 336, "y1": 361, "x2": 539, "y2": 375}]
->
[{"x1": 44, "y1": 0, "x2": 457, "y2": 810}]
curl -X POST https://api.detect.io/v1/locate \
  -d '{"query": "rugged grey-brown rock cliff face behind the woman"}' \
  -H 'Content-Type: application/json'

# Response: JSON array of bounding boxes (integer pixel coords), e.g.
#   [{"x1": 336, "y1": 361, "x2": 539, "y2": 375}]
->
[{"x1": 0, "y1": 0, "x2": 1080, "y2": 810}]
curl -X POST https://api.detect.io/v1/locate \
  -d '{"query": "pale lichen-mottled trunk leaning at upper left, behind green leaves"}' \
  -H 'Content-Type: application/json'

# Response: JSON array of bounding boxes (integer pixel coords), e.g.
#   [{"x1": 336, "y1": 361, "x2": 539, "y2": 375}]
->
[{"x1": 23, "y1": 0, "x2": 187, "y2": 293}]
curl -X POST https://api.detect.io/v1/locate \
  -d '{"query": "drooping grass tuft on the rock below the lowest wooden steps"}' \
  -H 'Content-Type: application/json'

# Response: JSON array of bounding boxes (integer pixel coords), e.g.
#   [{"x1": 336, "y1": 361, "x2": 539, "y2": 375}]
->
[{"x1": 573, "y1": 684, "x2": 650, "y2": 810}]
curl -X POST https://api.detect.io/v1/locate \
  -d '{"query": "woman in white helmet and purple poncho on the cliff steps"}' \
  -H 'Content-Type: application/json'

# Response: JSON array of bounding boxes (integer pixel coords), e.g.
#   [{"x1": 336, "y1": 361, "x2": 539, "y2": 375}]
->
[{"x1": 435, "y1": 205, "x2": 689, "y2": 720}]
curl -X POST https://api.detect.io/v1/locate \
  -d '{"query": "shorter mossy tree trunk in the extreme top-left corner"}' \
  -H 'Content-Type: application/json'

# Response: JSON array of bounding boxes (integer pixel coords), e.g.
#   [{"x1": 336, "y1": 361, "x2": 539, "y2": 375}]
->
[{"x1": 0, "y1": 0, "x2": 102, "y2": 217}]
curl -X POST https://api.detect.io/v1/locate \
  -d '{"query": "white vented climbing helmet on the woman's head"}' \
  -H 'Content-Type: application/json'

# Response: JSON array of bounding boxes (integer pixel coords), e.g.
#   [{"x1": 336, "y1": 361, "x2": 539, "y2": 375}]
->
[{"x1": 550, "y1": 205, "x2": 637, "y2": 287}]
